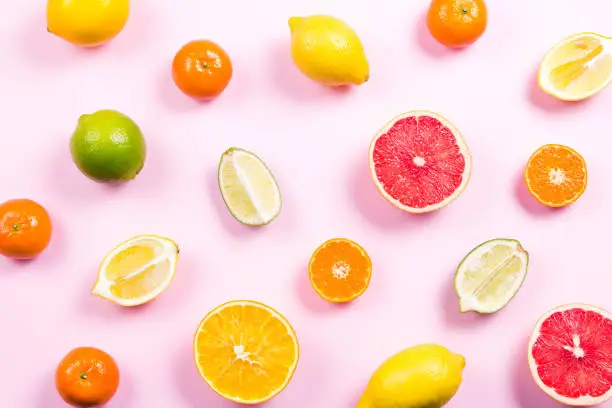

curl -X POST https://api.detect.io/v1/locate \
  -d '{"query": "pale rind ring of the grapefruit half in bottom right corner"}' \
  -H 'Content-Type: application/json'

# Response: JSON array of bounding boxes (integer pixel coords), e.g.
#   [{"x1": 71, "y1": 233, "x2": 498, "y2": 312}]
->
[{"x1": 527, "y1": 303, "x2": 612, "y2": 407}]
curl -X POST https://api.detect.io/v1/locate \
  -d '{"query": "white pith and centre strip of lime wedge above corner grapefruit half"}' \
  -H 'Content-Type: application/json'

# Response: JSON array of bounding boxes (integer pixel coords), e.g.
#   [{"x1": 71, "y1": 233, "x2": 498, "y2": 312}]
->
[{"x1": 455, "y1": 239, "x2": 529, "y2": 313}]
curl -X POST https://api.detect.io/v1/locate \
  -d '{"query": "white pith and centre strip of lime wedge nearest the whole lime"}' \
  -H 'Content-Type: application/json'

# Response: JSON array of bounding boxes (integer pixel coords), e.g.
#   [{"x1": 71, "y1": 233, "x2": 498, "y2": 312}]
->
[{"x1": 219, "y1": 148, "x2": 281, "y2": 225}]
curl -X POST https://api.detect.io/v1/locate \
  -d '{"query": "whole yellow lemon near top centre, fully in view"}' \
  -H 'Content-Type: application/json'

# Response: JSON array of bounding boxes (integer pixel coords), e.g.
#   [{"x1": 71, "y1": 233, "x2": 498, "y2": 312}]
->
[{"x1": 289, "y1": 15, "x2": 370, "y2": 86}]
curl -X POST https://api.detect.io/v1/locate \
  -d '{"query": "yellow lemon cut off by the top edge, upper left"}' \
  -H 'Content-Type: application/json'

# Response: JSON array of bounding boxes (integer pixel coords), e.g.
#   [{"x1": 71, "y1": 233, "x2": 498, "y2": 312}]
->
[{"x1": 47, "y1": 0, "x2": 130, "y2": 47}]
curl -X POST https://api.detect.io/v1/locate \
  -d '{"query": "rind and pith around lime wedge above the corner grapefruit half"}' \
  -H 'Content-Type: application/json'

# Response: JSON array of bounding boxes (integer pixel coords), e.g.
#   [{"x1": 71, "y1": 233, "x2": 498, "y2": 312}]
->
[{"x1": 455, "y1": 238, "x2": 529, "y2": 314}]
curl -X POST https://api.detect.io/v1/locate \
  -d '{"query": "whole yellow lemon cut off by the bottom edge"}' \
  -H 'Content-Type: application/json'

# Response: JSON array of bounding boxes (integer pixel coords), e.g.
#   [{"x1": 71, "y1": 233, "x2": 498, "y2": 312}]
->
[{"x1": 357, "y1": 344, "x2": 465, "y2": 408}]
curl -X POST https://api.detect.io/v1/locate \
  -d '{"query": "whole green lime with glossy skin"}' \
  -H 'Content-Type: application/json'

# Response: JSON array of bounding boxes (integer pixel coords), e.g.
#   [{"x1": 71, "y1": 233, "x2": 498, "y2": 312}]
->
[{"x1": 70, "y1": 110, "x2": 147, "y2": 183}]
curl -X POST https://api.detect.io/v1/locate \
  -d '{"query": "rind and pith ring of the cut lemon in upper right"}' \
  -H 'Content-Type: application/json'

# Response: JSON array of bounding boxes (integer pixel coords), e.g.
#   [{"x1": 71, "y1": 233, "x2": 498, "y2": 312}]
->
[{"x1": 538, "y1": 32, "x2": 612, "y2": 102}]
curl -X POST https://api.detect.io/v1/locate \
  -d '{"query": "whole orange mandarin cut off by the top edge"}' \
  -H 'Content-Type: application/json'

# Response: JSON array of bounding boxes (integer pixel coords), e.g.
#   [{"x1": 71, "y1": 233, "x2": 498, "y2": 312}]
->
[{"x1": 427, "y1": 0, "x2": 487, "y2": 48}]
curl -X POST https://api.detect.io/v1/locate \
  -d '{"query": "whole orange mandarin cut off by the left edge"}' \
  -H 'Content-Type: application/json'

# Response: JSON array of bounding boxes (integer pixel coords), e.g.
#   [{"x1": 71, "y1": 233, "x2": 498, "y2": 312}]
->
[{"x1": 0, "y1": 199, "x2": 52, "y2": 259}]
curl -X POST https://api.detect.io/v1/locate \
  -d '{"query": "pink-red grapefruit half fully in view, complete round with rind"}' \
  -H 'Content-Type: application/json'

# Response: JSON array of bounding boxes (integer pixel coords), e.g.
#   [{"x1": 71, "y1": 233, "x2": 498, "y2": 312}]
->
[{"x1": 370, "y1": 111, "x2": 472, "y2": 214}]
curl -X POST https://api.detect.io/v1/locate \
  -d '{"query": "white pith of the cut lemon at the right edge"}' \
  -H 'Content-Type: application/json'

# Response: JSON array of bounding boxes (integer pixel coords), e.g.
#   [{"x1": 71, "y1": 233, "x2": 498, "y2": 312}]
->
[{"x1": 538, "y1": 33, "x2": 612, "y2": 101}]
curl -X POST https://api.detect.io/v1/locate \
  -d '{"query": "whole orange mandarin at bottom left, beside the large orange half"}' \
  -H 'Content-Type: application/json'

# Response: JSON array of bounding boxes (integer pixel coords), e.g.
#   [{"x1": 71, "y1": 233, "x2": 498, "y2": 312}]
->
[{"x1": 55, "y1": 347, "x2": 119, "y2": 407}]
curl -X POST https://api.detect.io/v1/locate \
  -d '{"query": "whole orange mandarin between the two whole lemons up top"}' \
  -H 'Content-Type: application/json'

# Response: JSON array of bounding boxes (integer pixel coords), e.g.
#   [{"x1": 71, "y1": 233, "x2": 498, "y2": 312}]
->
[{"x1": 172, "y1": 40, "x2": 232, "y2": 99}]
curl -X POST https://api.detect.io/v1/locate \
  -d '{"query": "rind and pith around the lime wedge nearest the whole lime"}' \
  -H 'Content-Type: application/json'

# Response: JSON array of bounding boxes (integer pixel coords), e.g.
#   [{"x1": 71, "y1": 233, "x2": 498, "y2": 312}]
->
[{"x1": 217, "y1": 147, "x2": 282, "y2": 227}]
